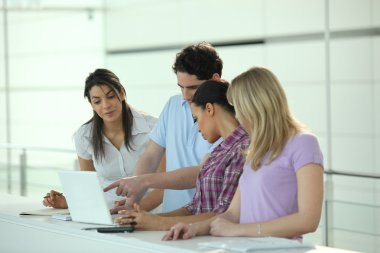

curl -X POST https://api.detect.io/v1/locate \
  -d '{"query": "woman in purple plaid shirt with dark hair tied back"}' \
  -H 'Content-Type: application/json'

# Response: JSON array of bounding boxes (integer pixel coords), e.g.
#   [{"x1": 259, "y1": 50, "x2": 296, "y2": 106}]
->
[{"x1": 115, "y1": 80, "x2": 250, "y2": 230}]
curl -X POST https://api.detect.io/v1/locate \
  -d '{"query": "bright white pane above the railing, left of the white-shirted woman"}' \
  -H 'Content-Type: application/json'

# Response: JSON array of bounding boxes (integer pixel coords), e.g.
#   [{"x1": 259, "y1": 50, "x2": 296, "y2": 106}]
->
[{"x1": 9, "y1": 11, "x2": 103, "y2": 147}]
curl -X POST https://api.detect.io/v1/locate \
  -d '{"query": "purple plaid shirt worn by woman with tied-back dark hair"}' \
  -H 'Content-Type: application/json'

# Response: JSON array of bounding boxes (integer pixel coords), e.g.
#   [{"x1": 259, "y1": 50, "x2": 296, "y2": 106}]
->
[{"x1": 184, "y1": 126, "x2": 250, "y2": 214}]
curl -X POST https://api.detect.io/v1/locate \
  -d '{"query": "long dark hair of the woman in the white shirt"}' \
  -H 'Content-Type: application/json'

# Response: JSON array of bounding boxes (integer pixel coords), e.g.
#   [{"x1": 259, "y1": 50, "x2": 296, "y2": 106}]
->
[{"x1": 84, "y1": 69, "x2": 133, "y2": 159}]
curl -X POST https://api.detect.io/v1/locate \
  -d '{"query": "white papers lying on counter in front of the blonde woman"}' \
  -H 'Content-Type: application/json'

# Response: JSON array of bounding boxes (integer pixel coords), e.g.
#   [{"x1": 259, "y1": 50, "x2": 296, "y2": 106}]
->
[{"x1": 198, "y1": 237, "x2": 314, "y2": 252}]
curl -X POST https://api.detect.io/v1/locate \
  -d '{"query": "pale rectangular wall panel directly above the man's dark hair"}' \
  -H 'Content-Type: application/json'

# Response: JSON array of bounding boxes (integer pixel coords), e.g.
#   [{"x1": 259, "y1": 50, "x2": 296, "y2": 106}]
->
[{"x1": 179, "y1": 0, "x2": 265, "y2": 44}]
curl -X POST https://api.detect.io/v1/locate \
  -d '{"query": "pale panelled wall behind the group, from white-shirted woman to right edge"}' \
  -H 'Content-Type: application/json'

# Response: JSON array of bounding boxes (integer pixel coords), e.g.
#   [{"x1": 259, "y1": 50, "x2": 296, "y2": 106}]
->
[{"x1": 106, "y1": 0, "x2": 380, "y2": 252}]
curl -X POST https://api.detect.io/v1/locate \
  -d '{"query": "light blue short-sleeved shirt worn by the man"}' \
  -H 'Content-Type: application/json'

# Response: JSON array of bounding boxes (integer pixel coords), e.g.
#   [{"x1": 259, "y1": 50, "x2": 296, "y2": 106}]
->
[{"x1": 151, "y1": 95, "x2": 220, "y2": 212}]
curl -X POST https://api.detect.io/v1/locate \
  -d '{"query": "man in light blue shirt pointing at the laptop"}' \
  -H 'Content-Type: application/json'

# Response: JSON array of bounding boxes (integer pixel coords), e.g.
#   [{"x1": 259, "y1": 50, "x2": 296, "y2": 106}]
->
[{"x1": 105, "y1": 43, "x2": 223, "y2": 212}]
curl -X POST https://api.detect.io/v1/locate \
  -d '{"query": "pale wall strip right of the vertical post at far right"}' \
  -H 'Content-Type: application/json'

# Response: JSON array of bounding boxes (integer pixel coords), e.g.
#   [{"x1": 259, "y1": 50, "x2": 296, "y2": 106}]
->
[{"x1": 330, "y1": 0, "x2": 380, "y2": 252}]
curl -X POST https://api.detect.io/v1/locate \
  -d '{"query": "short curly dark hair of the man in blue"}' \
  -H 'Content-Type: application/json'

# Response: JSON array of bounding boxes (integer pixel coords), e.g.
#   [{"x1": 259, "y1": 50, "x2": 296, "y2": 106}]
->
[{"x1": 172, "y1": 42, "x2": 223, "y2": 80}]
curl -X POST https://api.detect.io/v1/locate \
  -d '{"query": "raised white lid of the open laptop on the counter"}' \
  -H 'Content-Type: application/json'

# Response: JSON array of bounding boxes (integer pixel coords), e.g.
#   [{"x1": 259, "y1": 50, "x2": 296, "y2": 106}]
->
[{"x1": 58, "y1": 171, "x2": 115, "y2": 225}]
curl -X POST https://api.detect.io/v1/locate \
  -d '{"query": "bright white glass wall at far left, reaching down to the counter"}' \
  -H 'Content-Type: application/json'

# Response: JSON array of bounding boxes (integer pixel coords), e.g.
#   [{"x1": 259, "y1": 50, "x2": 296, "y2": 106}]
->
[{"x1": 0, "y1": 0, "x2": 104, "y2": 196}]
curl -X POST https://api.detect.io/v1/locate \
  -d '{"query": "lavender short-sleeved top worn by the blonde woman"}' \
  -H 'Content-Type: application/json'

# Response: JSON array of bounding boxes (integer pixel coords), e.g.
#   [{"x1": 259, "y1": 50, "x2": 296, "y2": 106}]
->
[{"x1": 239, "y1": 133, "x2": 323, "y2": 238}]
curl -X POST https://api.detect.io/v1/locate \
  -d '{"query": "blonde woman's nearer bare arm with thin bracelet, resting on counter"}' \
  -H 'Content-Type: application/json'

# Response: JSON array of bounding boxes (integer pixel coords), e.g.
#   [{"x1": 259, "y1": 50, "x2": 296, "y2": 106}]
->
[{"x1": 211, "y1": 164, "x2": 323, "y2": 238}]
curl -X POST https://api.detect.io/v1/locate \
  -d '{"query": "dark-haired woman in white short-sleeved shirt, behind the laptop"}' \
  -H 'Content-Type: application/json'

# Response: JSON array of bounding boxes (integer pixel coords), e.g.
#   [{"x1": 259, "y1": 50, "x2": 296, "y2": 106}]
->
[{"x1": 43, "y1": 69, "x2": 163, "y2": 210}]
